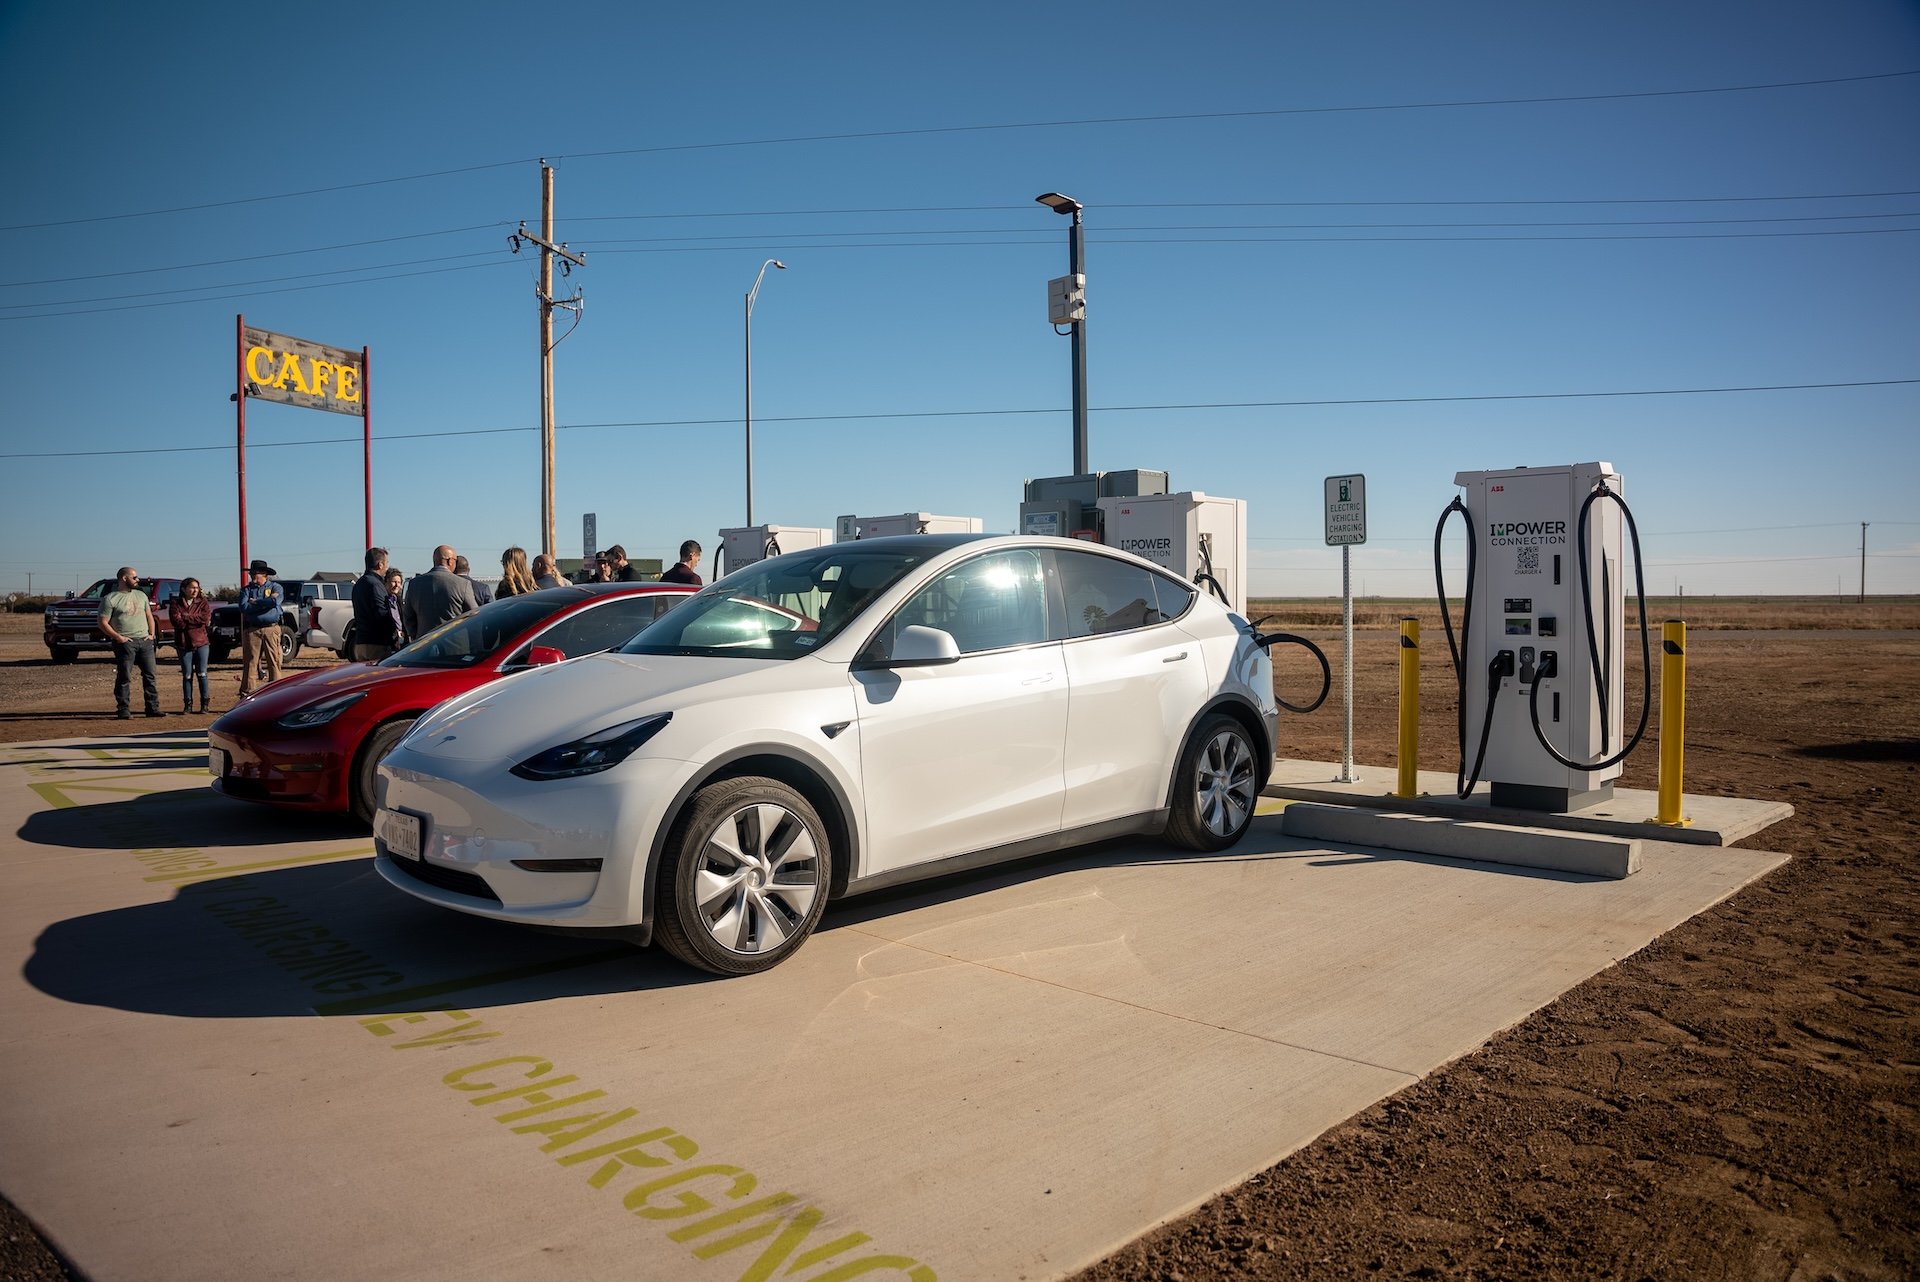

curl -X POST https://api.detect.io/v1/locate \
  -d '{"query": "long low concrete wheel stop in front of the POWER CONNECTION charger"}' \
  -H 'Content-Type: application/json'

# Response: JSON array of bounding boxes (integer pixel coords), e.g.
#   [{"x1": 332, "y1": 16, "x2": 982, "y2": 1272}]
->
[{"x1": 1281, "y1": 802, "x2": 1640, "y2": 879}]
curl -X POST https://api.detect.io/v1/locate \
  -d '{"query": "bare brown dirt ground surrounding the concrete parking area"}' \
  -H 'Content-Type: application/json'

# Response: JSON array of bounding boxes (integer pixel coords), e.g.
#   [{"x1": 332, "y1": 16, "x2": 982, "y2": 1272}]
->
[{"x1": 0, "y1": 599, "x2": 1920, "y2": 1282}]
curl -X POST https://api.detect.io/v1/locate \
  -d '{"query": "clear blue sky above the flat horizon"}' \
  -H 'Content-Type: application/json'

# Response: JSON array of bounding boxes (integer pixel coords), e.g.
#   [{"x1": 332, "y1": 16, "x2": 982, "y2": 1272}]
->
[{"x1": 0, "y1": 0, "x2": 1920, "y2": 595}]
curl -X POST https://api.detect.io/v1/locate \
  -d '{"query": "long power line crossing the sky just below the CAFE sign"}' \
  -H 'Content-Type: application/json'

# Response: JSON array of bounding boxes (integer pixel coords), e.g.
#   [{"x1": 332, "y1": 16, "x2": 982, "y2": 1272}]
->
[{"x1": 0, "y1": 378, "x2": 1920, "y2": 460}]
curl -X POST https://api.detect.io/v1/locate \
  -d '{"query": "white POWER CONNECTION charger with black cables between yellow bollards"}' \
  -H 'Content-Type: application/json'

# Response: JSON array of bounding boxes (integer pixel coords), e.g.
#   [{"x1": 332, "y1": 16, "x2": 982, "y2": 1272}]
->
[{"x1": 1434, "y1": 463, "x2": 1651, "y2": 812}]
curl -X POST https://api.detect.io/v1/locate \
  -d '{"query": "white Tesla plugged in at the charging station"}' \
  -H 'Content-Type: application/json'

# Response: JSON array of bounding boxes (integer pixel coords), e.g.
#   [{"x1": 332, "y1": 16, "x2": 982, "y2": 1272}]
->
[{"x1": 374, "y1": 535, "x2": 1279, "y2": 975}]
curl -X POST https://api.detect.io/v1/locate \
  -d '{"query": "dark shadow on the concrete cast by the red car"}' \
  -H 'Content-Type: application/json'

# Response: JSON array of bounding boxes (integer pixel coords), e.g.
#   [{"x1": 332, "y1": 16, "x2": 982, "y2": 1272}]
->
[{"x1": 19, "y1": 786, "x2": 372, "y2": 850}]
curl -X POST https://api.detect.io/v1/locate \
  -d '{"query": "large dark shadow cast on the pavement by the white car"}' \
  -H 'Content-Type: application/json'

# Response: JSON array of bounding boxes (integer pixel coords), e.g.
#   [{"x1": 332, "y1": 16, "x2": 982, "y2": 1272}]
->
[{"x1": 21, "y1": 858, "x2": 712, "y2": 1019}]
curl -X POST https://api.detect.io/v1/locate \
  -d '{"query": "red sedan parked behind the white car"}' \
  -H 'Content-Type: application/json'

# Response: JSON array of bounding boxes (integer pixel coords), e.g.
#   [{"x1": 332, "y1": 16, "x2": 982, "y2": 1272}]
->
[{"x1": 207, "y1": 583, "x2": 695, "y2": 823}]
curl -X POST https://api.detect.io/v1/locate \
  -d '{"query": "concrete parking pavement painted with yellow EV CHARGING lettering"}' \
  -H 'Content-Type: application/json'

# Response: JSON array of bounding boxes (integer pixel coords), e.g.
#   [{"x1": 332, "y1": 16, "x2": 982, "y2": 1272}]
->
[{"x1": 0, "y1": 737, "x2": 1786, "y2": 1282}]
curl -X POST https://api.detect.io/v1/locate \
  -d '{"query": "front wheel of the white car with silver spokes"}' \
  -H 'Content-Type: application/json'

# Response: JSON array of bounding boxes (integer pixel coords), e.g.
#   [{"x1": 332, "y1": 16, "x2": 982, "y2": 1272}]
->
[{"x1": 655, "y1": 777, "x2": 833, "y2": 975}]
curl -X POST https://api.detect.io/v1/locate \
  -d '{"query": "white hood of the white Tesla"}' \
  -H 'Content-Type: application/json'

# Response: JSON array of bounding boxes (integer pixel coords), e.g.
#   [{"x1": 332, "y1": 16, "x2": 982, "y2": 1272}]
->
[{"x1": 405, "y1": 653, "x2": 791, "y2": 762}]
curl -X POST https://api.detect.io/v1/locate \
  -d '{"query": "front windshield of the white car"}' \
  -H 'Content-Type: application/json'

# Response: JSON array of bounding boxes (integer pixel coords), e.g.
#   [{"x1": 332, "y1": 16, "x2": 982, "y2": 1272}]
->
[{"x1": 620, "y1": 541, "x2": 933, "y2": 658}]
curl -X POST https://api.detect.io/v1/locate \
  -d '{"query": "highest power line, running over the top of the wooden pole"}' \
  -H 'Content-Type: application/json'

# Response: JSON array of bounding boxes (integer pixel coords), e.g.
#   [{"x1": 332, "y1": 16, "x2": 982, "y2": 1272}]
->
[{"x1": 11, "y1": 69, "x2": 1920, "y2": 232}]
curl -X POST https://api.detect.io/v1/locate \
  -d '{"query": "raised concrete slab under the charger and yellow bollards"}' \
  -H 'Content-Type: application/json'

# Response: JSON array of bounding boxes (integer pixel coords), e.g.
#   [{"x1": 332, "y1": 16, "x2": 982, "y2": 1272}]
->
[{"x1": 1265, "y1": 756, "x2": 1793, "y2": 846}]
